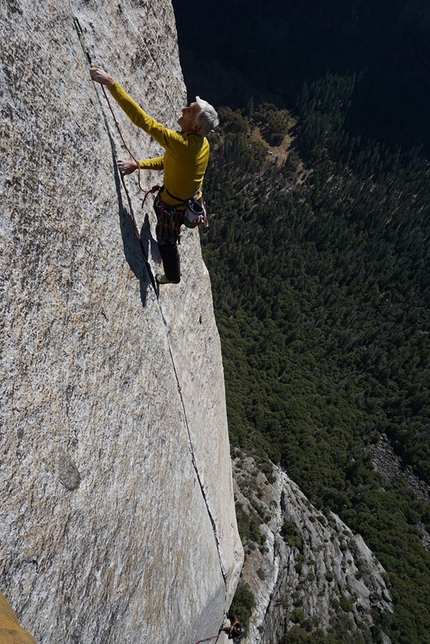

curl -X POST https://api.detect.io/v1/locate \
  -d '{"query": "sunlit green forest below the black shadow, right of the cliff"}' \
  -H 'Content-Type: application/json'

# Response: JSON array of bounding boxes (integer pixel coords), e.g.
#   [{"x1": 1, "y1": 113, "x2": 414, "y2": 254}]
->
[{"x1": 201, "y1": 75, "x2": 430, "y2": 644}]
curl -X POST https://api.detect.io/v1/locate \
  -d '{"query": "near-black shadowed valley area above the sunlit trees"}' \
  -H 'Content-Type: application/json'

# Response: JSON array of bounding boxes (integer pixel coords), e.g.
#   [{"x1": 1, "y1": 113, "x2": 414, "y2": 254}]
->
[{"x1": 173, "y1": 0, "x2": 430, "y2": 156}]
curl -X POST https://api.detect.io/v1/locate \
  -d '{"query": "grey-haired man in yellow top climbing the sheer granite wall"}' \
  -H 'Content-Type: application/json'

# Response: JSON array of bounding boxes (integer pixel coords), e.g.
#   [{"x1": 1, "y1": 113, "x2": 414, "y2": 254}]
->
[{"x1": 90, "y1": 66, "x2": 219, "y2": 284}]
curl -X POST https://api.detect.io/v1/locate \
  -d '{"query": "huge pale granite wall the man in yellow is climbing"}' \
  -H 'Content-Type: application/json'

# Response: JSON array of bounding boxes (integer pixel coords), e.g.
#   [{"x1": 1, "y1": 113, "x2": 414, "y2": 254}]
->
[{"x1": 0, "y1": 0, "x2": 242, "y2": 644}]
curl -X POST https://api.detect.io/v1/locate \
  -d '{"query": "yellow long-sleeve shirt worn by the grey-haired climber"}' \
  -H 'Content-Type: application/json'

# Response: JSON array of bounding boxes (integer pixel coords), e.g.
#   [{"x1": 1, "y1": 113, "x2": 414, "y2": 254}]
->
[{"x1": 109, "y1": 83, "x2": 210, "y2": 206}]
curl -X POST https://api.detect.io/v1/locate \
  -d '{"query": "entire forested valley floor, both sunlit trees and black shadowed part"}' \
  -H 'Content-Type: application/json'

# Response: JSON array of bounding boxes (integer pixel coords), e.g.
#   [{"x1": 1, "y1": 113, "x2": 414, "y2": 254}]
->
[{"x1": 173, "y1": 0, "x2": 430, "y2": 644}]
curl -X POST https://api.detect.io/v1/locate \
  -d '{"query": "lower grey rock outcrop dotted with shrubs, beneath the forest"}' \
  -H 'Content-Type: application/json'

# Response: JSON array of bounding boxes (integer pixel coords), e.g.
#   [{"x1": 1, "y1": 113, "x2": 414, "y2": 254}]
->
[{"x1": 234, "y1": 458, "x2": 392, "y2": 644}]
